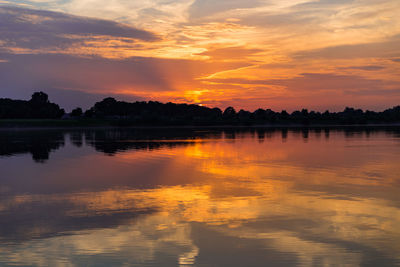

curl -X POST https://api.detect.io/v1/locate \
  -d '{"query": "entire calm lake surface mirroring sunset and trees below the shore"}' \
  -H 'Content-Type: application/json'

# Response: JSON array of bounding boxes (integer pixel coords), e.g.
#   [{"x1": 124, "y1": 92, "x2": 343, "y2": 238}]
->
[{"x1": 0, "y1": 129, "x2": 400, "y2": 267}]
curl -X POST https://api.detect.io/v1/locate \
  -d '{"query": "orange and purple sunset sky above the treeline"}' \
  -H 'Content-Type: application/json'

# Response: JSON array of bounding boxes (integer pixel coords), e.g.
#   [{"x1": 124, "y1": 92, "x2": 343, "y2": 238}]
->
[{"x1": 0, "y1": 0, "x2": 400, "y2": 111}]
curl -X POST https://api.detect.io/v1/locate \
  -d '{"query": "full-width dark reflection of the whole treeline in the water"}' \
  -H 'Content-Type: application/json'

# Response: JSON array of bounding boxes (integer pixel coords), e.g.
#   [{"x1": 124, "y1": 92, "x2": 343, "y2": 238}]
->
[{"x1": 0, "y1": 127, "x2": 400, "y2": 163}]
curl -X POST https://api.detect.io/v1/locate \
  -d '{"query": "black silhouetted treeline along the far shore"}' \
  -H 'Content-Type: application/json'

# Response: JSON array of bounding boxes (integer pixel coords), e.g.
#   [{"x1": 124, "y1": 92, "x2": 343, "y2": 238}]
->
[{"x1": 0, "y1": 92, "x2": 400, "y2": 126}]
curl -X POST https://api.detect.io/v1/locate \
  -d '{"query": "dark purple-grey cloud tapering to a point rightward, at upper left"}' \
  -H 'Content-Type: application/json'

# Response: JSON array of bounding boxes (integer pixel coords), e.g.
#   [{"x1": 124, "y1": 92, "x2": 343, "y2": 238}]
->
[{"x1": 0, "y1": 6, "x2": 157, "y2": 50}]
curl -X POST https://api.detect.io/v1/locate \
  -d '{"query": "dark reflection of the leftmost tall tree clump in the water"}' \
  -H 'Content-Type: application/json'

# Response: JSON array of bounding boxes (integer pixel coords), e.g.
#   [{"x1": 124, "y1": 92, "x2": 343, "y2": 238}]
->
[{"x1": 0, "y1": 131, "x2": 64, "y2": 163}]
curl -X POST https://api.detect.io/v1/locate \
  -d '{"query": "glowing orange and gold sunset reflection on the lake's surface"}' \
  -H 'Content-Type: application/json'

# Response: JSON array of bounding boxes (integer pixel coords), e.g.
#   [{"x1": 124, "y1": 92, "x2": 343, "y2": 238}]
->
[{"x1": 1, "y1": 130, "x2": 400, "y2": 266}]
